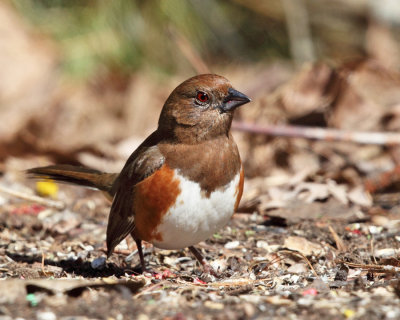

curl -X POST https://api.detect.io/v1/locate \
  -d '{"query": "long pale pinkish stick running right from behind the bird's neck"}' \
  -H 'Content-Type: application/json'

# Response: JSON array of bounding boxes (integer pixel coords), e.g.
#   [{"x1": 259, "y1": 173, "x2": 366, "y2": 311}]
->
[{"x1": 232, "y1": 121, "x2": 400, "y2": 146}]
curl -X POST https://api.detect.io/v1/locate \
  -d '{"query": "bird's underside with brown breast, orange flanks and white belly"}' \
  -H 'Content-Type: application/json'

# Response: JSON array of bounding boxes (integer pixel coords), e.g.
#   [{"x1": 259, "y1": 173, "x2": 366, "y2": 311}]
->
[{"x1": 133, "y1": 137, "x2": 243, "y2": 249}]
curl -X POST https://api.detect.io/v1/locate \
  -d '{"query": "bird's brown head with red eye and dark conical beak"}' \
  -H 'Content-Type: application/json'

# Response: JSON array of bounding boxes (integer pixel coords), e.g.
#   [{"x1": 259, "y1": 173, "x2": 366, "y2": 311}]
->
[{"x1": 158, "y1": 74, "x2": 250, "y2": 143}]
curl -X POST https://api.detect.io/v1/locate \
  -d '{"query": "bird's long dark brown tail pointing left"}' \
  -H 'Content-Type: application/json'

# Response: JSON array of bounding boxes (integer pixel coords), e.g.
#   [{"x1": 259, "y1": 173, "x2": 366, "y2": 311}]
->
[{"x1": 27, "y1": 165, "x2": 118, "y2": 197}]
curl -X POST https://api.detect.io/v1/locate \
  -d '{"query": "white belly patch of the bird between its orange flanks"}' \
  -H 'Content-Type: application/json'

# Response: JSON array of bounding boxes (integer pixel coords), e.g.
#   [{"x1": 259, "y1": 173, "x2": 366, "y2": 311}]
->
[{"x1": 153, "y1": 172, "x2": 240, "y2": 249}]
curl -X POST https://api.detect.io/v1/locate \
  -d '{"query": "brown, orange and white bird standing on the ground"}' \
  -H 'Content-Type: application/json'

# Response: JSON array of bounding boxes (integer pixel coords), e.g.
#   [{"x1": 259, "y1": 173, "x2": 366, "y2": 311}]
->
[{"x1": 27, "y1": 74, "x2": 251, "y2": 274}]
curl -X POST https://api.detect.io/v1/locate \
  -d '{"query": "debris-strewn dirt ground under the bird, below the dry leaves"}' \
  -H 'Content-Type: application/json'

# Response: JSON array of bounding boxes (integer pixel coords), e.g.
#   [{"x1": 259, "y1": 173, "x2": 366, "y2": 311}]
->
[{"x1": 0, "y1": 169, "x2": 400, "y2": 320}]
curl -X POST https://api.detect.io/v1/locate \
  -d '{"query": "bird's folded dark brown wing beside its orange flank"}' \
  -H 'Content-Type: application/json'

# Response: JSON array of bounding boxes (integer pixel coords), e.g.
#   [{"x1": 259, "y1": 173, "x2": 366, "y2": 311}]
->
[{"x1": 107, "y1": 132, "x2": 165, "y2": 256}]
